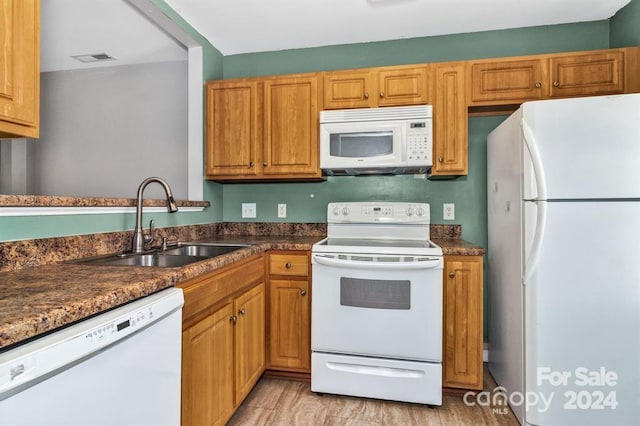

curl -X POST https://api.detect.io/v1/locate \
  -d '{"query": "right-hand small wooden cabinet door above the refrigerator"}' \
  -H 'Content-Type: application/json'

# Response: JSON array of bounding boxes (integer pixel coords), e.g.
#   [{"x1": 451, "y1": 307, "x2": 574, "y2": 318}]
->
[{"x1": 549, "y1": 51, "x2": 624, "y2": 97}]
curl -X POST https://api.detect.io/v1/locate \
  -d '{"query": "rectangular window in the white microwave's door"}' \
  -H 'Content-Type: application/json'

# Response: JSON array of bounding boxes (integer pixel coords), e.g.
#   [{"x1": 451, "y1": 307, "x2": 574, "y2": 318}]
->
[{"x1": 329, "y1": 131, "x2": 393, "y2": 158}]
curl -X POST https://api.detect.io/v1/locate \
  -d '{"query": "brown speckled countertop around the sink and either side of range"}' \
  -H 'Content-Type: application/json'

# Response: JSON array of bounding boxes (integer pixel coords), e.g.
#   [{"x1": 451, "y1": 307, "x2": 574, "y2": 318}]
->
[{"x1": 0, "y1": 227, "x2": 484, "y2": 351}]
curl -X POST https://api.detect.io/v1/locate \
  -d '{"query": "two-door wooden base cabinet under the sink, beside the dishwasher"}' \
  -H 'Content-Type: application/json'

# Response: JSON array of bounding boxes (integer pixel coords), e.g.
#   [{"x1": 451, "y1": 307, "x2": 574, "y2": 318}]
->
[{"x1": 179, "y1": 255, "x2": 265, "y2": 426}]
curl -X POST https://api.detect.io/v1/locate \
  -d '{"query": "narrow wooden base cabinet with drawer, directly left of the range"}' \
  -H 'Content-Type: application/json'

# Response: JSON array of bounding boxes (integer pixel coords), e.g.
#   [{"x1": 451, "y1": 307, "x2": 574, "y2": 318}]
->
[{"x1": 267, "y1": 251, "x2": 311, "y2": 374}]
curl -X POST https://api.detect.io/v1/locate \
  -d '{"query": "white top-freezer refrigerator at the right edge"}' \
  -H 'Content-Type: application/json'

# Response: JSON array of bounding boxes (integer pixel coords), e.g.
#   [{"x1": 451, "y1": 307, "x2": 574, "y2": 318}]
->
[{"x1": 487, "y1": 94, "x2": 640, "y2": 426}]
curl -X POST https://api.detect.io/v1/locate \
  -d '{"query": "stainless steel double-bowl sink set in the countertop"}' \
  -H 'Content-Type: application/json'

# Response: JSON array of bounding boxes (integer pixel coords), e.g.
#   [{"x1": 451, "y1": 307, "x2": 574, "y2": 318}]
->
[{"x1": 69, "y1": 243, "x2": 248, "y2": 268}]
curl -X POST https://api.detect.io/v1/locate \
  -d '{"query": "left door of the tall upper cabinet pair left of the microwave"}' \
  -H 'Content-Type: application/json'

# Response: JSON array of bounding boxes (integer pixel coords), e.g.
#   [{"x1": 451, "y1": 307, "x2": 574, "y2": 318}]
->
[{"x1": 206, "y1": 81, "x2": 261, "y2": 178}]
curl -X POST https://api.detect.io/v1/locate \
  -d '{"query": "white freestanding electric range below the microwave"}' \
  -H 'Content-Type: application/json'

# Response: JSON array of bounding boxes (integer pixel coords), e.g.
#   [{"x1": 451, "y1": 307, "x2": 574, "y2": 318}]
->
[{"x1": 311, "y1": 202, "x2": 443, "y2": 405}]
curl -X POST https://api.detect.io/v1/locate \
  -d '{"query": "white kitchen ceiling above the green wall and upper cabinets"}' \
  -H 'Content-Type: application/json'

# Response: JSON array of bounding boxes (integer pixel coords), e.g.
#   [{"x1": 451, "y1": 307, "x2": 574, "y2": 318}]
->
[{"x1": 164, "y1": 0, "x2": 630, "y2": 55}]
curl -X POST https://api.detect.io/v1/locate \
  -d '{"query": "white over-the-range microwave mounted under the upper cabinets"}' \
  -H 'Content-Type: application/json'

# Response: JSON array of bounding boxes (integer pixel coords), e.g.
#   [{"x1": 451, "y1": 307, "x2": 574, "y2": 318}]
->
[{"x1": 320, "y1": 105, "x2": 433, "y2": 175}]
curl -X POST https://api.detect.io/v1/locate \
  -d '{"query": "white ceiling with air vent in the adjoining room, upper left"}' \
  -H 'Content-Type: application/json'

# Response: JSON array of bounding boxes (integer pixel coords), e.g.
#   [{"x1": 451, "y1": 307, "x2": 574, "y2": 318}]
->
[{"x1": 40, "y1": 0, "x2": 187, "y2": 72}]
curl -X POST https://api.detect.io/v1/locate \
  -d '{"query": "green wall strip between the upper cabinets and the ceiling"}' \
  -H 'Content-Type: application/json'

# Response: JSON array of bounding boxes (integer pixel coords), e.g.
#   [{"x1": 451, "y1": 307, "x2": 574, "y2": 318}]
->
[{"x1": 224, "y1": 21, "x2": 609, "y2": 78}]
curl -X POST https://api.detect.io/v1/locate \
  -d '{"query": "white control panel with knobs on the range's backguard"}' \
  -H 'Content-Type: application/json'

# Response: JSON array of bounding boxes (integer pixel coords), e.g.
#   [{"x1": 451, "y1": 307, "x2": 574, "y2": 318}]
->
[{"x1": 327, "y1": 202, "x2": 430, "y2": 224}]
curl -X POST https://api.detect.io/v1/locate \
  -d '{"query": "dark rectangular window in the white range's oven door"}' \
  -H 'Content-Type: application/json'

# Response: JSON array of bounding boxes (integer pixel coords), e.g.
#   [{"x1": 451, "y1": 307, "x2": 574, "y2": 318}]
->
[{"x1": 340, "y1": 277, "x2": 411, "y2": 310}]
